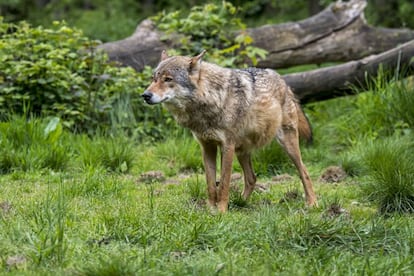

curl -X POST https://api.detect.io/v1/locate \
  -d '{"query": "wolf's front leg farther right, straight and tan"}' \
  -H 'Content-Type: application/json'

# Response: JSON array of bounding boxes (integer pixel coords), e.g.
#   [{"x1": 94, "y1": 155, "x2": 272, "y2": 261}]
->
[{"x1": 217, "y1": 144, "x2": 235, "y2": 213}]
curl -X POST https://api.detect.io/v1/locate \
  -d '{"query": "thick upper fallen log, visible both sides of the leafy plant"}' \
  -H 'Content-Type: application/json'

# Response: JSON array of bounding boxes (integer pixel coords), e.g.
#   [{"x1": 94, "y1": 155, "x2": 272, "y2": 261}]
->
[{"x1": 99, "y1": 0, "x2": 414, "y2": 71}]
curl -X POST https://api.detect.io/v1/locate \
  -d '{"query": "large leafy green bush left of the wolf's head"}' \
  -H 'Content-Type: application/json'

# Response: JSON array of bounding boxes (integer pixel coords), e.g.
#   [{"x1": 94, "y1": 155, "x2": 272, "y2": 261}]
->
[{"x1": 0, "y1": 18, "x2": 171, "y2": 136}]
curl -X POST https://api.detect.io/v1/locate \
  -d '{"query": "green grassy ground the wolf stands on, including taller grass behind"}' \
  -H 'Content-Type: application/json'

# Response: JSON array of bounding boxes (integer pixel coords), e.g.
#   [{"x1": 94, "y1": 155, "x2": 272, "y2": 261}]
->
[{"x1": 0, "y1": 81, "x2": 414, "y2": 275}]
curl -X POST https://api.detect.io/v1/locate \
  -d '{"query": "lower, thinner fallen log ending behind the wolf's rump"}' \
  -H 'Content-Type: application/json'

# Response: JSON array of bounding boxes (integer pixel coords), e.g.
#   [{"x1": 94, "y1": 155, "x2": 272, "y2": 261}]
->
[{"x1": 283, "y1": 40, "x2": 414, "y2": 103}]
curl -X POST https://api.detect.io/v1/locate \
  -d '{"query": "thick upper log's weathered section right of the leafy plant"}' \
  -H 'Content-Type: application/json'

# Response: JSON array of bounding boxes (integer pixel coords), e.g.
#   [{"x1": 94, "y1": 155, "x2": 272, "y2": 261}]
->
[{"x1": 249, "y1": 0, "x2": 414, "y2": 68}]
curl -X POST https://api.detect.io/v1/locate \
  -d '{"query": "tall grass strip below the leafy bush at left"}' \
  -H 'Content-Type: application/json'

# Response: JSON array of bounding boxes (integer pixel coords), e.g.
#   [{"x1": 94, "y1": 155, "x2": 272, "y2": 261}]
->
[{"x1": 0, "y1": 116, "x2": 135, "y2": 173}]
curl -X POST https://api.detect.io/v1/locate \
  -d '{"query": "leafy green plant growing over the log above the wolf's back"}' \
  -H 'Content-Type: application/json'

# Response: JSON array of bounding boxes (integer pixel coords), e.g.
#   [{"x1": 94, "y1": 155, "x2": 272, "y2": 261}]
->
[{"x1": 152, "y1": 1, "x2": 267, "y2": 67}]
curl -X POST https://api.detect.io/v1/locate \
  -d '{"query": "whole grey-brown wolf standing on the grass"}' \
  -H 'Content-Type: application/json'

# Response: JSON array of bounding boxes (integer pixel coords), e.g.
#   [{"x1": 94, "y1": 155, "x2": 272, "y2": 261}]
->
[{"x1": 142, "y1": 52, "x2": 316, "y2": 212}]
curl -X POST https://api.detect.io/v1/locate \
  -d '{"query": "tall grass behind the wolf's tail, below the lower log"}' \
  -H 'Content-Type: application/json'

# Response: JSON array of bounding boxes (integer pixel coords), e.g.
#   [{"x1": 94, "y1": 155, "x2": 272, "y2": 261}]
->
[{"x1": 305, "y1": 72, "x2": 414, "y2": 166}]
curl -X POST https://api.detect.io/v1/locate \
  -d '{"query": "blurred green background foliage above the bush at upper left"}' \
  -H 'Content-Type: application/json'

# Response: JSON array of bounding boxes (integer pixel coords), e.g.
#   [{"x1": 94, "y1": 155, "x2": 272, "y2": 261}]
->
[{"x1": 0, "y1": 0, "x2": 144, "y2": 41}]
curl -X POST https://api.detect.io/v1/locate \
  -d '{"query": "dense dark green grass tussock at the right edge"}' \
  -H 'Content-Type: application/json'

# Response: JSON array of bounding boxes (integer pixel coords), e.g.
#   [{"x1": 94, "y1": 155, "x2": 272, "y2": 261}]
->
[{"x1": 362, "y1": 137, "x2": 414, "y2": 214}]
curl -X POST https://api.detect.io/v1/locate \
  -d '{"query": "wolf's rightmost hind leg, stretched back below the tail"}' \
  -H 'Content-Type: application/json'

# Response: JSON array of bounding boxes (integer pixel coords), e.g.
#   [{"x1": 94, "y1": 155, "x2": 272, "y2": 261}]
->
[{"x1": 277, "y1": 126, "x2": 318, "y2": 206}]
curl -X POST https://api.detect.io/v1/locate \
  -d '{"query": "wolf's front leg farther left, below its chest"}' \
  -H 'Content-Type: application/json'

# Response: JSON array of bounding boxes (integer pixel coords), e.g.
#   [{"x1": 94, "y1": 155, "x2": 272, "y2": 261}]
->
[{"x1": 200, "y1": 141, "x2": 217, "y2": 209}]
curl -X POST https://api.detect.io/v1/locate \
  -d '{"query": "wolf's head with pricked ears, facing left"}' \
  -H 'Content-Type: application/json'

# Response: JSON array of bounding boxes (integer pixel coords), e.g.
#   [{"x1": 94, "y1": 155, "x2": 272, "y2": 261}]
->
[{"x1": 141, "y1": 50, "x2": 206, "y2": 104}]
